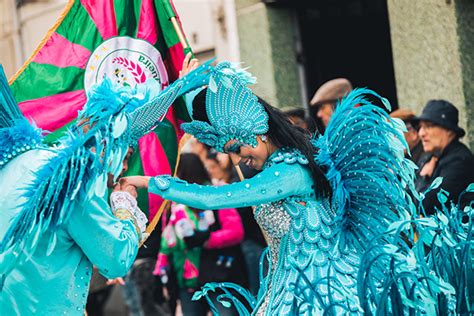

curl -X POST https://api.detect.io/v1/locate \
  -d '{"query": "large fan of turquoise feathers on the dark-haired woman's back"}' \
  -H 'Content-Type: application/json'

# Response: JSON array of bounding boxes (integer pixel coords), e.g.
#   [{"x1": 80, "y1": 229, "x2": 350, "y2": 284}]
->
[{"x1": 315, "y1": 89, "x2": 415, "y2": 251}]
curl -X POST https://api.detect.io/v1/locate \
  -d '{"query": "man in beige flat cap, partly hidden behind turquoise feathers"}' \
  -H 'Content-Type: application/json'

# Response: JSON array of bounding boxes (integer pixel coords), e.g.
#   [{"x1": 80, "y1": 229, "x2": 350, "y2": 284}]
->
[{"x1": 310, "y1": 78, "x2": 352, "y2": 128}]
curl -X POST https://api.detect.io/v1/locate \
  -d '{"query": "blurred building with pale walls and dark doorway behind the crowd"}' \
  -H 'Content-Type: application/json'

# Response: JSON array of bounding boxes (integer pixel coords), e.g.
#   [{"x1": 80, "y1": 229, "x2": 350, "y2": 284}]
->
[{"x1": 0, "y1": 0, "x2": 474, "y2": 148}]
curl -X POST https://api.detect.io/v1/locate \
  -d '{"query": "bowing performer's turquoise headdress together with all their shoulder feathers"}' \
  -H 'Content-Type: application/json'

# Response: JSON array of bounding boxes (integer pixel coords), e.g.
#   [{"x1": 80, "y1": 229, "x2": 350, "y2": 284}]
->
[{"x1": 0, "y1": 64, "x2": 210, "y2": 292}]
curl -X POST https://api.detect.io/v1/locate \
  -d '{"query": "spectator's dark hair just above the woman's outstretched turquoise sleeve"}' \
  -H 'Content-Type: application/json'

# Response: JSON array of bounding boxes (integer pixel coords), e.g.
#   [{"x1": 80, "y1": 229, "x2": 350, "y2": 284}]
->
[{"x1": 176, "y1": 153, "x2": 211, "y2": 184}]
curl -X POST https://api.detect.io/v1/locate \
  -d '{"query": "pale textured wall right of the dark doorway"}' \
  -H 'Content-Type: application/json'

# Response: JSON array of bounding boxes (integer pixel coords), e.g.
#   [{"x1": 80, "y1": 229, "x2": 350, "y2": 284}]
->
[{"x1": 388, "y1": 0, "x2": 474, "y2": 148}]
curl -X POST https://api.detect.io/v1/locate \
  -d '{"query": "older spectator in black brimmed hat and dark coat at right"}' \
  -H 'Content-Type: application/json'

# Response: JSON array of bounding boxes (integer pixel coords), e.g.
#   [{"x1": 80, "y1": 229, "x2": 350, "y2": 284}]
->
[{"x1": 415, "y1": 100, "x2": 474, "y2": 214}]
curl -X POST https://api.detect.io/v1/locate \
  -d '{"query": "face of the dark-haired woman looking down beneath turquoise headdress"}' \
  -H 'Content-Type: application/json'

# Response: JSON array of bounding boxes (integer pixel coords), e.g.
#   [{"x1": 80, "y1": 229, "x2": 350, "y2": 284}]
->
[{"x1": 224, "y1": 136, "x2": 276, "y2": 170}]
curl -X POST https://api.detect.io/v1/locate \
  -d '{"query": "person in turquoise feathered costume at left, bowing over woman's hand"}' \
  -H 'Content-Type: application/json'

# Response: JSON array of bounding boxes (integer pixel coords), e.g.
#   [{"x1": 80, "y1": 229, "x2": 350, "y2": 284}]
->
[{"x1": 0, "y1": 59, "x2": 207, "y2": 315}]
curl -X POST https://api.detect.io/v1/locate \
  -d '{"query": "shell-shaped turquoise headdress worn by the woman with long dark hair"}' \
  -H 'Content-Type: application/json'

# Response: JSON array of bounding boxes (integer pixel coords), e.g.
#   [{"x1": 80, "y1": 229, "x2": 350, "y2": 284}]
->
[{"x1": 181, "y1": 62, "x2": 268, "y2": 152}]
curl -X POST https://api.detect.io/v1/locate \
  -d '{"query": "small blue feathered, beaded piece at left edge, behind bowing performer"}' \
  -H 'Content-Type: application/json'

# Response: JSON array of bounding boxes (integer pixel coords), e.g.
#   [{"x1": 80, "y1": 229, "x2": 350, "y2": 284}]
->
[{"x1": 0, "y1": 65, "x2": 43, "y2": 169}]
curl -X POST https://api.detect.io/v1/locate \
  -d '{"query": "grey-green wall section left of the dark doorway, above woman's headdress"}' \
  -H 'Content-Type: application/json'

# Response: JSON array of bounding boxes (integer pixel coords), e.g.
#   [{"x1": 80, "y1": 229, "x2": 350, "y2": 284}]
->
[{"x1": 236, "y1": 0, "x2": 302, "y2": 107}]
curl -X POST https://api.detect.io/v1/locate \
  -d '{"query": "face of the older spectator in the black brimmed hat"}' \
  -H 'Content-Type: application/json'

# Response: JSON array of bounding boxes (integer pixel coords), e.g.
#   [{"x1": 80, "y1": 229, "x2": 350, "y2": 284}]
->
[{"x1": 418, "y1": 121, "x2": 456, "y2": 152}]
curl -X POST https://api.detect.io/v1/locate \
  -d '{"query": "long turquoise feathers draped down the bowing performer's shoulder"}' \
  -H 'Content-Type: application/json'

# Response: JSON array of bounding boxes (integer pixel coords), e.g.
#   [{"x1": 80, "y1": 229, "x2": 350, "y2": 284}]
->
[{"x1": 0, "y1": 128, "x2": 97, "y2": 284}]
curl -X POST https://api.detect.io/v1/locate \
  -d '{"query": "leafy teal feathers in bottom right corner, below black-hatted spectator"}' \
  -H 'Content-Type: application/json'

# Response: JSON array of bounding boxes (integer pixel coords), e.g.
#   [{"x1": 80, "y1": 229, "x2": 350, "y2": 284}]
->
[{"x1": 358, "y1": 180, "x2": 474, "y2": 315}]
